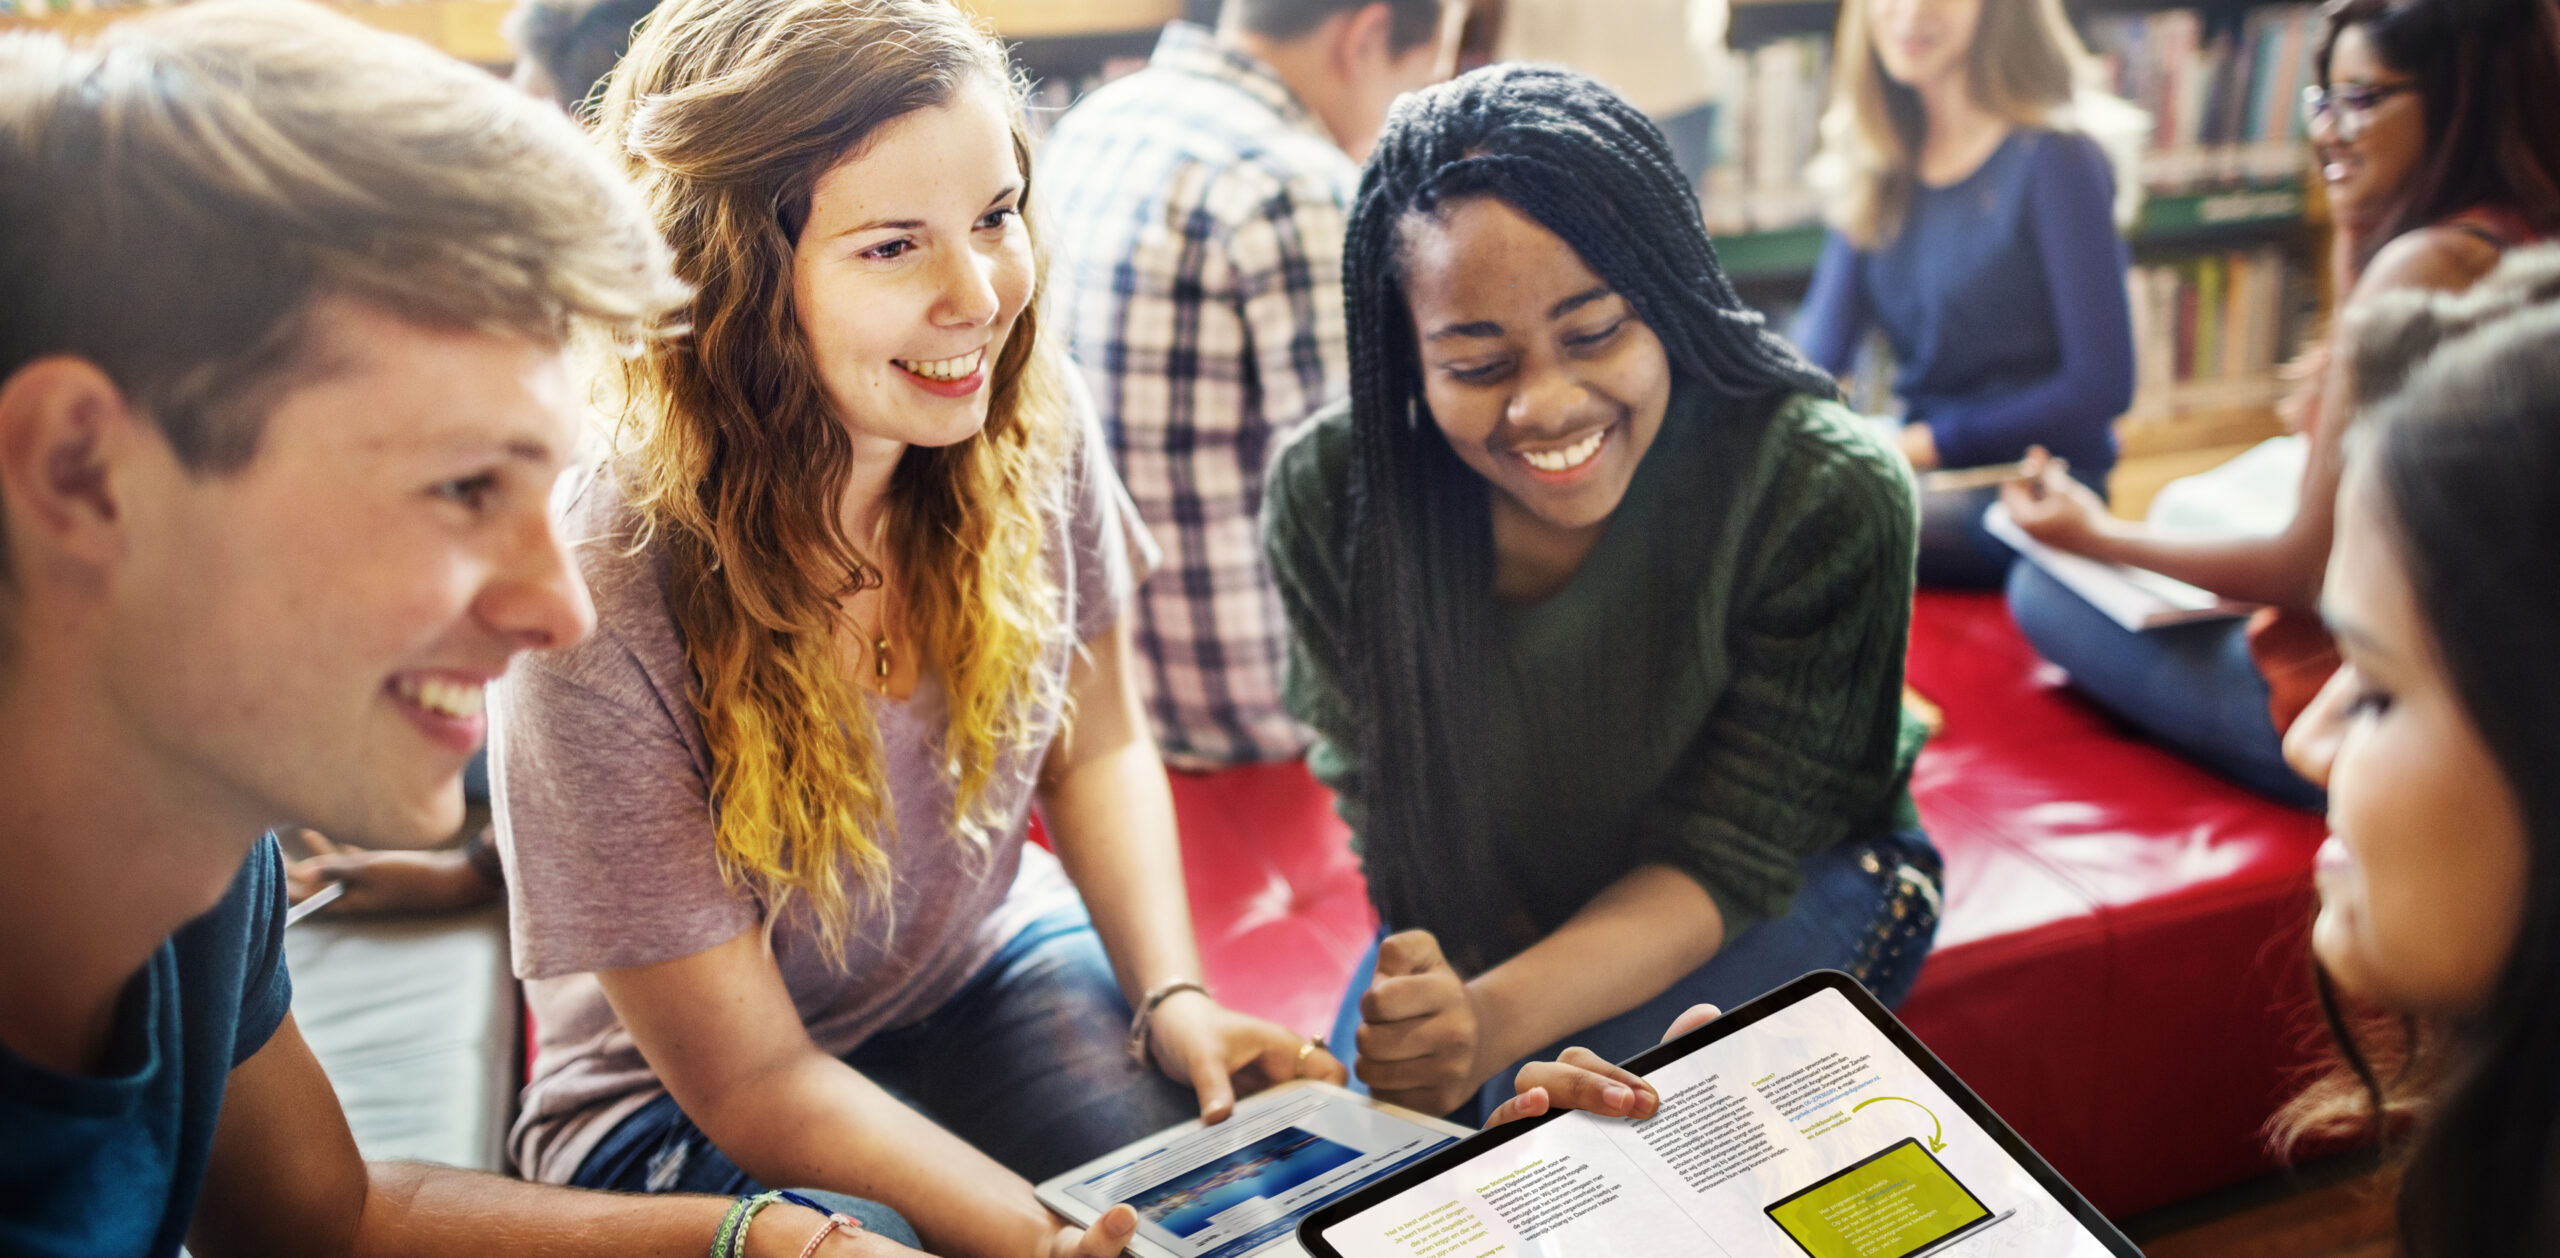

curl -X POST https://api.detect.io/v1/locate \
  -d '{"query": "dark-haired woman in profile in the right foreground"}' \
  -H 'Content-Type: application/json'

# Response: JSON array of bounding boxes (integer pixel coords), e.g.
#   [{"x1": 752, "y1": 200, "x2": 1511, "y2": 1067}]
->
[{"x1": 2286, "y1": 246, "x2": 2560, "y2": 1258}]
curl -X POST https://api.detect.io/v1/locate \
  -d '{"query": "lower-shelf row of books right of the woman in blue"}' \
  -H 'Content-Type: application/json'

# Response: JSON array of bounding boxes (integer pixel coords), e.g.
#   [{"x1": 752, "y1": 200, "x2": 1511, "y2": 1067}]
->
[{"x1": 2125, "y1": 246, "x2": 2317, "y2": 397}]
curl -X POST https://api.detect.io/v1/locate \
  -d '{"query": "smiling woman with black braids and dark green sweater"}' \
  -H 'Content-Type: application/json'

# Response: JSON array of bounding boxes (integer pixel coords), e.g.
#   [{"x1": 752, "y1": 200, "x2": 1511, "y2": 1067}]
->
[{"x1": 1265, "y1": 67, "x2": 1938, "y2": 1115}]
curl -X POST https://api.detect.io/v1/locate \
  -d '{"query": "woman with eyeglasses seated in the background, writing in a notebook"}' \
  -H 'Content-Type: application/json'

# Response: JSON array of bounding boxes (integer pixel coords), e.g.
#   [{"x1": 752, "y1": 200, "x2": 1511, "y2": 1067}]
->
[{"x1": 2002, "y1": 0, "x2": 2560, "y2": 807}]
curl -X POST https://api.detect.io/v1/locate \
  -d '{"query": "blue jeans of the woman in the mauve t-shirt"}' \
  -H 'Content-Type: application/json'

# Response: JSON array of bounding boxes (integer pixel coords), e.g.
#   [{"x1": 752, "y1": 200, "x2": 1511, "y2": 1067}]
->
[{"x1": 571, "y1": 907, "x2": 1201, "y2": 1199}]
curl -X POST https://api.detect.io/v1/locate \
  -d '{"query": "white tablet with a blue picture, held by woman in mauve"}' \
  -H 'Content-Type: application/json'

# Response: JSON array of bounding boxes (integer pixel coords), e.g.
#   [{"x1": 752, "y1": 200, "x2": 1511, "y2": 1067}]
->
[{"x1": 1037, "y1": 1079, "x2": 1475, "y2": 1258}]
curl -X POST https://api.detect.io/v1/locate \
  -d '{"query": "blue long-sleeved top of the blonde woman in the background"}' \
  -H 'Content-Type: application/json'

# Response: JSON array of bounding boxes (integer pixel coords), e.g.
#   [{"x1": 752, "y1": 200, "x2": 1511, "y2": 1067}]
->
[{"x1": 1795, "y1": 128, "x2": 2132, "y2": 479}]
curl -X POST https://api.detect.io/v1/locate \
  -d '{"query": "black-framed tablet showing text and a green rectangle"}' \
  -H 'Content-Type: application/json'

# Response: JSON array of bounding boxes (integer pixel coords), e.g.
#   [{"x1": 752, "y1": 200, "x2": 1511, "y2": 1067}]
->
[{"x1": 1298, "y1": 971, "x2": 2143, "y2": 1258}]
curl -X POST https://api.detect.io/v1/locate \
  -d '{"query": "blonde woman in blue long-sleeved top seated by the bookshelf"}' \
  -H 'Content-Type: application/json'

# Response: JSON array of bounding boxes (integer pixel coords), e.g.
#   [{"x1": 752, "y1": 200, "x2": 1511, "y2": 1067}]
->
[{"x1": 1795, "y1": 0, "x2": 2140, "y2": 587}]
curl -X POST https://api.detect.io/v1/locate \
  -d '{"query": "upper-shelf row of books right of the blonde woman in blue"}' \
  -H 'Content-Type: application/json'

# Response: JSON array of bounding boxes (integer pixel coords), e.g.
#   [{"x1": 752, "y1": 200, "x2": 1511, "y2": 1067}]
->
[{"x1": 2089, "y1": 5, "x2": 2319, "y2": 190}]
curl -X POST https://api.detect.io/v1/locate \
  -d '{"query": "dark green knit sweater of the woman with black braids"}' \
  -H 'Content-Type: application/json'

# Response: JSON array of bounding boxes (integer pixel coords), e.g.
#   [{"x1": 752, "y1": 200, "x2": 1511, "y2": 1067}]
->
[{"x1": 1262, "y1": 389, "x2": 1925, "y2": 943}]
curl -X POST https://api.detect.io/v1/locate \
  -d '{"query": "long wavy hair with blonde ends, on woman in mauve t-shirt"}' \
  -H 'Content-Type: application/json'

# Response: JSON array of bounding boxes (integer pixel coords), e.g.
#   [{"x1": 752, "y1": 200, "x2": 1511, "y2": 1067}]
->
[{"x1": 599, "y1": 0, "x2": 1073, "y2": 956}]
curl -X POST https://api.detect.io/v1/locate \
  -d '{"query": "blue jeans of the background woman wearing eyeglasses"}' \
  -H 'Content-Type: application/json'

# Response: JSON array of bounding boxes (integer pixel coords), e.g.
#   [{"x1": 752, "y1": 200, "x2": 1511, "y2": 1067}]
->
[{"x1": 2010, "y1": 564, "x2": 2327, "y2": 810}]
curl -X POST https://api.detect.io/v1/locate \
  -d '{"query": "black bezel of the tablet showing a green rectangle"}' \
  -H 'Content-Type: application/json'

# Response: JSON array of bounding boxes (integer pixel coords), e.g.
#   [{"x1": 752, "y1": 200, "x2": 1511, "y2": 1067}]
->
[{"x1": 1298, "y1": 968, "x2": 2143, "y2": 1258}]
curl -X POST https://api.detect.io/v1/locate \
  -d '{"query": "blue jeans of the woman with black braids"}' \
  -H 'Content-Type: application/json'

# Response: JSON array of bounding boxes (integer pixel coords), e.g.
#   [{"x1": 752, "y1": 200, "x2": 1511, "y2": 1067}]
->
[{"x1": 1329, "y1": 830, "x2": 1943, "y2": 1125}]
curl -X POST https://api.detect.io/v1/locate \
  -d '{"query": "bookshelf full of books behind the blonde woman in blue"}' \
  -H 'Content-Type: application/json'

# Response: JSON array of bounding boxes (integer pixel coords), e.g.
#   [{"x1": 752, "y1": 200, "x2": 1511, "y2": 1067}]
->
[{"x1": 1700, "y1": 0, "x2": 2330, "y2": 459}]
